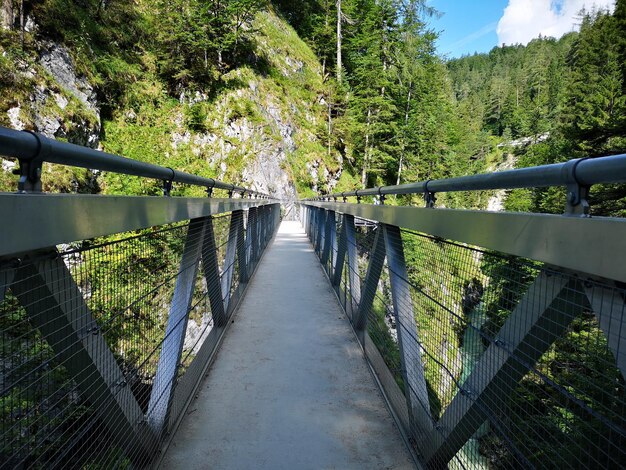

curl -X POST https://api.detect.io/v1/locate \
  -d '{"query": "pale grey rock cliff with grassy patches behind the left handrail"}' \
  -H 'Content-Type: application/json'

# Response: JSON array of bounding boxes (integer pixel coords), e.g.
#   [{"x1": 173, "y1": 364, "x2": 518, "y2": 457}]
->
[{"x1": 0, "y1": 11, "x2": 332, "y2": 201}]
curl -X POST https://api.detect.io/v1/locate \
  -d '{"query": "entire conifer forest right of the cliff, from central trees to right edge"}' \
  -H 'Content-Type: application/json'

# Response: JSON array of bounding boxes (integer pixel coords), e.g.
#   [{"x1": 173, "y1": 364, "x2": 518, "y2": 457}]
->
[{"x1": 276, "y1": 0, "x2": 626, "y2": 216}]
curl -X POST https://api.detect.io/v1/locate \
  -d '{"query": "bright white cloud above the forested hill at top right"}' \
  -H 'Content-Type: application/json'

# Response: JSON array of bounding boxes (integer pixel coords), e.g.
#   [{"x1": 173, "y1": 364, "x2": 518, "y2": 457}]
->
[{"x1": 496, "y1": 0, "x2": 615, "y2": 44}]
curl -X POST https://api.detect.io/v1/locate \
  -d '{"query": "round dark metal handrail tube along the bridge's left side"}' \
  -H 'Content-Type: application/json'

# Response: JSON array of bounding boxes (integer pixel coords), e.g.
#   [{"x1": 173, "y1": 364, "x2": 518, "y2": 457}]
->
[{"x1": 0, "y1": 126, "x2": 269, "y2": 199}]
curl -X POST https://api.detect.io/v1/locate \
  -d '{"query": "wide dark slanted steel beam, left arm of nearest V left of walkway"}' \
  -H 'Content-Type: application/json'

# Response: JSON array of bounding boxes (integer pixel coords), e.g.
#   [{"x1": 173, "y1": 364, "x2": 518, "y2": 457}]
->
[{"x1": 11, "y1": 250, "x2": 157, "y2": 465}]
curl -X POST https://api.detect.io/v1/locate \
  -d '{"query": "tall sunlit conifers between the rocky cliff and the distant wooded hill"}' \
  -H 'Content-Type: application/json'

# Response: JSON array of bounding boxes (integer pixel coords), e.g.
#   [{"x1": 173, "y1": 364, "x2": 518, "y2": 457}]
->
[{"x1": 274, "y1": 0, "x2": 495, "y2": 189}]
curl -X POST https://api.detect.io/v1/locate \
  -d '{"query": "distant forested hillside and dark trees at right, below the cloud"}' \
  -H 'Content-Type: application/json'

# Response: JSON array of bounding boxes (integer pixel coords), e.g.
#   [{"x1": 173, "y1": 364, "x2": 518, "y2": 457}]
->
[{"x1": 447, "y1": 0, "x2": 626, "y2": 217}]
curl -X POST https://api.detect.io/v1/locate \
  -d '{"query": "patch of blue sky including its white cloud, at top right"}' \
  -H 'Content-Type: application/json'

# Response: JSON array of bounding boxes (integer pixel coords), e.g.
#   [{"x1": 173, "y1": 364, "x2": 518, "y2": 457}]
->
[{"x1": 428, "y1": 0, "x2": 615, "y2": 58}]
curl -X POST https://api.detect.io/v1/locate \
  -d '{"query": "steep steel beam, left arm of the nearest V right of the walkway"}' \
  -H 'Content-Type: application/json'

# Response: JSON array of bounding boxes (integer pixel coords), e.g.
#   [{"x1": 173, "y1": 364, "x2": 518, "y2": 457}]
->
[{"x1": 379, "y1": 224, "x2": 433, "y2": 442}]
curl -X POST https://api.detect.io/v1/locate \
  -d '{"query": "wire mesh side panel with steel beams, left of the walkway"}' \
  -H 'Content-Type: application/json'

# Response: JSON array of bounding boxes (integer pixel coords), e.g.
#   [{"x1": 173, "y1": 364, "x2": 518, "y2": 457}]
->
[{"x1": 0, "y1": 208, "x2": 276, "y2": 468}]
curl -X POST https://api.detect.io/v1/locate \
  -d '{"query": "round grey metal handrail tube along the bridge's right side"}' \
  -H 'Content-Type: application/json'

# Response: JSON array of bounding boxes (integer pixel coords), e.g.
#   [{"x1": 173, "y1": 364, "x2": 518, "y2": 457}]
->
[{"x1": 305, "y1": 154, "x2": 626, "y2": 201}]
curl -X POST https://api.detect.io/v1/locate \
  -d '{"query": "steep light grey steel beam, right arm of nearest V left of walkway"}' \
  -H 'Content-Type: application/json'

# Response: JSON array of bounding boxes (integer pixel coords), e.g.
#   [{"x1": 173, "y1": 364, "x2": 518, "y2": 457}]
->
[{"x1": 147, "y1": 217, "x2": 210, "y2": 435}]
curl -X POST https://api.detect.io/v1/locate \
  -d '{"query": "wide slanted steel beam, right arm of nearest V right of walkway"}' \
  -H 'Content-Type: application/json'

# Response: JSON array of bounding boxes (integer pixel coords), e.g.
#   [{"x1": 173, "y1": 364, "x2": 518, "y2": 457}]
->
[{"x1": 422, "y1": 273, "x2": 586, "y2": 468}]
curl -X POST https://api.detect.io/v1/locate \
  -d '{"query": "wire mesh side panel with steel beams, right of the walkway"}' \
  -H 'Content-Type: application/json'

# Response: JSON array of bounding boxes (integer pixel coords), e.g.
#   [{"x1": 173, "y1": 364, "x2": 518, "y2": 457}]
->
[{"x1": 306, "y1": 207, "x2": 626, "y2": 468}]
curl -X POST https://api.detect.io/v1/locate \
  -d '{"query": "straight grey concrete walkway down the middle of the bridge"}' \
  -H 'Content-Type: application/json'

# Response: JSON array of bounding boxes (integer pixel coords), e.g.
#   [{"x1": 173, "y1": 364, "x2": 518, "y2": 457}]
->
[{"x1": 161, "y1": 222, "x2": 413, "y2": 470}]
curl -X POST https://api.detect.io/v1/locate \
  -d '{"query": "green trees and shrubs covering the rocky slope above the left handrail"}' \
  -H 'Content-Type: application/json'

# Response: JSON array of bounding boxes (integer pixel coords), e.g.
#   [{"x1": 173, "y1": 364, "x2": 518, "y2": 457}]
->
[{"x1": 0, "y1": 0, "x2": 330, "y2": 195}]
